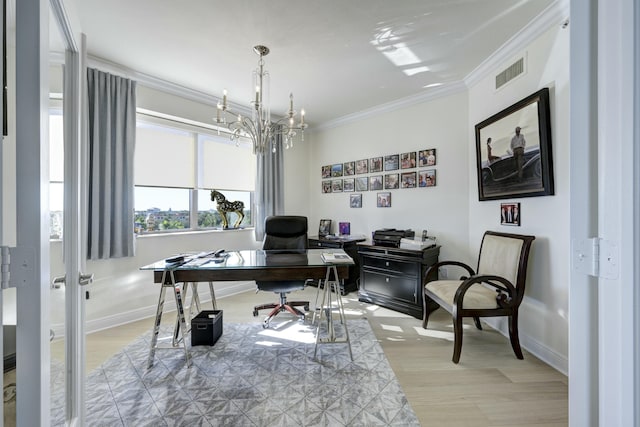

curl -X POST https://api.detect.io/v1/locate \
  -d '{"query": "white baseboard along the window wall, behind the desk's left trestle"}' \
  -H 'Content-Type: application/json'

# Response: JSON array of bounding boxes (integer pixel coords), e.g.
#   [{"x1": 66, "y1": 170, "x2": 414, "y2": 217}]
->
[{"x1": 51, "y1": 282, "x2": 256, "y2": 339}]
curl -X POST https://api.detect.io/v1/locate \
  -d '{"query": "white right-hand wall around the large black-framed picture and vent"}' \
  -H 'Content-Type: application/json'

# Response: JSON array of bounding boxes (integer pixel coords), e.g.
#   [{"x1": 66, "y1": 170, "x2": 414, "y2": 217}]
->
[{"x1": 467, "y1": 26, "x2": 570, "y2": 373}]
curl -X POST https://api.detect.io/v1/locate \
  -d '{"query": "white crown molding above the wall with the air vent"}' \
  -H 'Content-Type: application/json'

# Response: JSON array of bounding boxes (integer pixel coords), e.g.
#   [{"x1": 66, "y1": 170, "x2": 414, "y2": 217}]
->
[{"x1": 463, "y1": 0, "x2": 569, "y2": 87}]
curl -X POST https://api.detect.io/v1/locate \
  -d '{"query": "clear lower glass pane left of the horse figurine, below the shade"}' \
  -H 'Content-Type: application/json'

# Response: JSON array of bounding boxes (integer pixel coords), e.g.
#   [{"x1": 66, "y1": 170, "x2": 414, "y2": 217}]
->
[{"x1": 135, "y1": 187, "x2": 190, "y2": 233}]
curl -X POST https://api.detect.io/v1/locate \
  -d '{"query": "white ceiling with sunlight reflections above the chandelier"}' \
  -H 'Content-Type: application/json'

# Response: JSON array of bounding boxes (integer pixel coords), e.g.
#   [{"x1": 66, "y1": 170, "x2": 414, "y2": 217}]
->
[{"x1": 63, "y1": 0, "x2": 554, "y2": 126}]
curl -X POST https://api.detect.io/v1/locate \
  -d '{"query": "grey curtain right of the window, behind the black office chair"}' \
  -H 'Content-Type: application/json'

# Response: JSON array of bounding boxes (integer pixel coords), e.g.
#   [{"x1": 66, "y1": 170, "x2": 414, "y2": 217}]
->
[{"x1": 254, "y1": 135, "x2": 284, "y2": 242}]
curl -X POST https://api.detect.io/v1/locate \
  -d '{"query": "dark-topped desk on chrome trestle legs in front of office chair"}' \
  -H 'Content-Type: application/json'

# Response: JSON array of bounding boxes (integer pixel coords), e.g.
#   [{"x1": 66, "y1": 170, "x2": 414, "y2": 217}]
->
[{"x1": 140, "y1": 249, "x2": 354, "y2": 367}]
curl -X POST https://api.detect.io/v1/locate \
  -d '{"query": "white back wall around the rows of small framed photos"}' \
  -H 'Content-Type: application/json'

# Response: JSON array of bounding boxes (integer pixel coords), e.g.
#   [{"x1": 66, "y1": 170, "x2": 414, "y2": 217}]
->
[{"x1": 309, "y1": 92, "x2": 470, "y2": 260}]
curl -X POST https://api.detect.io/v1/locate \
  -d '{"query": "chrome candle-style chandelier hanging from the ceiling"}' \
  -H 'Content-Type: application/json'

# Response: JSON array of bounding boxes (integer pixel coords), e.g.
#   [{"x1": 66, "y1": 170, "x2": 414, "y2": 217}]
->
[{"x1": 216, "y1": 45, "x2": 307, "y2": 154}]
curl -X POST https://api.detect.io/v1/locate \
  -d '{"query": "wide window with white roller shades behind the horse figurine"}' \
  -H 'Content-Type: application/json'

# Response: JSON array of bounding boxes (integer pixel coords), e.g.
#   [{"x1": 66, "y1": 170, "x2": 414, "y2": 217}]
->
[{"x1": 134, "y1": 114, "x2": 256, "y2": 234}]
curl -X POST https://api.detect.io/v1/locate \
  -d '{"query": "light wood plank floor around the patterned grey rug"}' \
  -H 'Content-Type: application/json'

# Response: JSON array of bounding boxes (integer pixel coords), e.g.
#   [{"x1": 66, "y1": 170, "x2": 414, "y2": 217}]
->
[{"x1": 17, "y1": 287, "x2": 568, "y2": 427}]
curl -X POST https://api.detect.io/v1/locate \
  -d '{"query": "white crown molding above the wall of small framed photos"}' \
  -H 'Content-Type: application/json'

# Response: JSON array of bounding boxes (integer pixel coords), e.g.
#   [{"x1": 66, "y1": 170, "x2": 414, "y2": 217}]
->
[{"x1": 313, "y1": 82, "x2": 467, "y2": 131}]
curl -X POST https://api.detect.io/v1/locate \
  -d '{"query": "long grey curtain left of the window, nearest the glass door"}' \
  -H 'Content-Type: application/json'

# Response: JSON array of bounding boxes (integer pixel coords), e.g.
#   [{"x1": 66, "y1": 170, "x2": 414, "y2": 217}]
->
[{"x1": 87, "y1": 68, "x2": 136, "y2": 259}]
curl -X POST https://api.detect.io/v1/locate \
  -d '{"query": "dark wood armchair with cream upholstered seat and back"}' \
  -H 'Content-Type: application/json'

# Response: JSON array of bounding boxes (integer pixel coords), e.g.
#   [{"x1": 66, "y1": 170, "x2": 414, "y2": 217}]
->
[{"x1": 422, "y1": 231, "x2": 535, "y2": 363}]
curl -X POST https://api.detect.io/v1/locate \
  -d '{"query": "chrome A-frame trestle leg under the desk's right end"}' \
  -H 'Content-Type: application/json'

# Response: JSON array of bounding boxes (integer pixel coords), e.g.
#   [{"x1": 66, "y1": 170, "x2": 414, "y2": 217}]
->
[{"x1": 313, "y1": 265, "x2": 353, "y2": 360}]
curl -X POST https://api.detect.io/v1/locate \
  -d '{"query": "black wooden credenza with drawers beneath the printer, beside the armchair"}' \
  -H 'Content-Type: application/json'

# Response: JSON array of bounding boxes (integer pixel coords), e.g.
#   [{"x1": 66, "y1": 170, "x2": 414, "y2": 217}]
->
[{"x1": 358, "y1": 244, "x2": 440, "y2": 319}]
